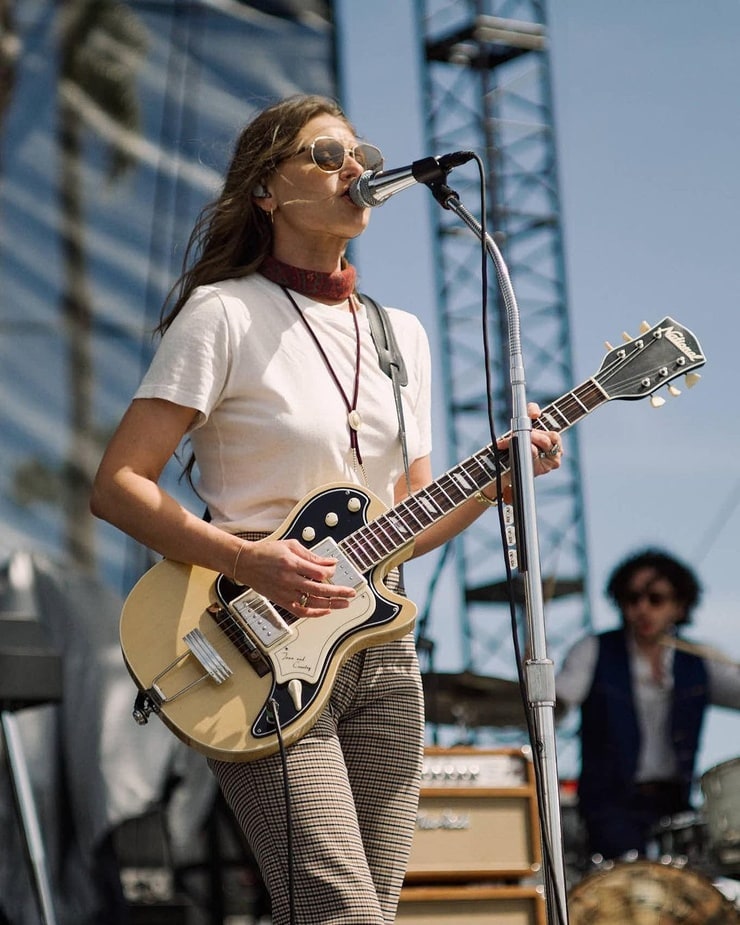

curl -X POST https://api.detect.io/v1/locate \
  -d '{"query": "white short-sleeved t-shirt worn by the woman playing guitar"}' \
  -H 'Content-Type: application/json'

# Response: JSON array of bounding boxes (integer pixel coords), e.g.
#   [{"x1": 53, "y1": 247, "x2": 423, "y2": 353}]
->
[{"x1": 134, "y1": 274, "x2": 431, "y2": 532}]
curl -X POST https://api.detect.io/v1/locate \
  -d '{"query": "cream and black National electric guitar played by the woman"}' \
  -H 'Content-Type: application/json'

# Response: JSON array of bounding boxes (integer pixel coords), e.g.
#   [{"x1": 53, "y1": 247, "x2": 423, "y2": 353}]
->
[{"x1": 120, "y1": 317, "x2": 705, "y2": 761}]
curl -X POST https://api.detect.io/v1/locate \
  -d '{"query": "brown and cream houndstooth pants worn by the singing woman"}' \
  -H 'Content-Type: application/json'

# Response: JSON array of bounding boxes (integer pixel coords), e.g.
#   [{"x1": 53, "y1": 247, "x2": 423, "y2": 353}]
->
[{"x1": 209, "y1": 634, "x2": 424, "y2": 925}]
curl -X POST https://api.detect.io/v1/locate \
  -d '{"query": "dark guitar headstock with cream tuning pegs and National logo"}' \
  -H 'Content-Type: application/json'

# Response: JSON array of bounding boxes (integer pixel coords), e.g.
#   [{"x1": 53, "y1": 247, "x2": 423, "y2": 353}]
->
[{"x1": 594, "y1": 316, "x2": 706, "y2": 406}]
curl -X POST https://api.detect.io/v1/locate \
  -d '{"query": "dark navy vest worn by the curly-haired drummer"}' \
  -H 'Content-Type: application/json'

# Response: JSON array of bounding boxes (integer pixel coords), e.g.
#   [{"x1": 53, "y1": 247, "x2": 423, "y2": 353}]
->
[{"x1": 579, "y1": 629, "x2": 709, "y2": 810}]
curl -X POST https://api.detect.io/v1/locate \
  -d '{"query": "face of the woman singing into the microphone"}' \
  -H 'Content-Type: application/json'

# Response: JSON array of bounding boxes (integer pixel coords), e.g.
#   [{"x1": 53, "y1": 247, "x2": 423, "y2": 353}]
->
[{"x1": 259, "y1": 115, "x2": 370, "y2": 269}]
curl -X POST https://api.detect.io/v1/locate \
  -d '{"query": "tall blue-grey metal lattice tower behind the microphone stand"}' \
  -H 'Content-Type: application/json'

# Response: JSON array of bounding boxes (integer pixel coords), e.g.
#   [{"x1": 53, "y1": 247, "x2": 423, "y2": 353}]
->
[{"x1": 417, "y1": 0, "x2": 590, "y2": 678}]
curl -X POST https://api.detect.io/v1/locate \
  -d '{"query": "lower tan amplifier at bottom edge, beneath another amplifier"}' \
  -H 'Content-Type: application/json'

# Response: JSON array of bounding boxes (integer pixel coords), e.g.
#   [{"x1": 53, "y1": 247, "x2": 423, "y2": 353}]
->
[{"x1": 396, "y1": 886, "x2": 546, "y2": 925}]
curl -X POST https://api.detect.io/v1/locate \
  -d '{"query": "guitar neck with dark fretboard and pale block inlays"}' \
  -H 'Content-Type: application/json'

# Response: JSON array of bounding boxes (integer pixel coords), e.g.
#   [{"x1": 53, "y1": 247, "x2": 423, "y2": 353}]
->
[{"x1": 339, "y1": 377, "x2": 609, "y2": 573}]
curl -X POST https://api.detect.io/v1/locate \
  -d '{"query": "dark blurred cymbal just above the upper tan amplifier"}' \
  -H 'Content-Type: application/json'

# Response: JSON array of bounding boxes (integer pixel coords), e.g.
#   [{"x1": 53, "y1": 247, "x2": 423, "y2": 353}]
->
[{"x1": 422, "y1": 671, "x2": 560, "y2": 727}]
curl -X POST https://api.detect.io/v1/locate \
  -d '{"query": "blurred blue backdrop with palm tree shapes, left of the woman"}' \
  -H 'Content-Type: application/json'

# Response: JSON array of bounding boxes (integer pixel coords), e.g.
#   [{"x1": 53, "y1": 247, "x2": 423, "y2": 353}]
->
[{"x1": 0, "y1": 0, "x2": 337, "y2": 592}]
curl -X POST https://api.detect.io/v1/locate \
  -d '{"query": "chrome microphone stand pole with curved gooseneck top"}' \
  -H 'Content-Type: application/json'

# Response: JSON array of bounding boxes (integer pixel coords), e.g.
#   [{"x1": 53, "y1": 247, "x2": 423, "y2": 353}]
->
[{"x1": 427, "y1": 182, "x2": 568, "y2": 925}]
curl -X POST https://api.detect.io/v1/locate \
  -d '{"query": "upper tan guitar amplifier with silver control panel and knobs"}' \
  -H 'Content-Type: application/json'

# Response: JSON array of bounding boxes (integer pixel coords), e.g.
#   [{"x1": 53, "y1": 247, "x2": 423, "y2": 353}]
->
[{"x1": 406, "y1": 747, "x2": 541, "y2": 883}]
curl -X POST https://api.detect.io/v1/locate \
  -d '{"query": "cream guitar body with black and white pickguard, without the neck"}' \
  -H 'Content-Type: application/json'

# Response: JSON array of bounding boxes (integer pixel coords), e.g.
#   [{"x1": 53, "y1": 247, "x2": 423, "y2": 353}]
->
[{"x1": 120, "y1": 485, "x2": 416, "y2": 761}]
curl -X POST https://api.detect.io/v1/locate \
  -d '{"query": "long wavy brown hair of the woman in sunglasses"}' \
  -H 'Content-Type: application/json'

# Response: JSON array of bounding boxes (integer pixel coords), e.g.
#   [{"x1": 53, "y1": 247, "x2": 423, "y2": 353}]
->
[{"x1": 157, "y1": 94, "x2": 353, "y2": 334}]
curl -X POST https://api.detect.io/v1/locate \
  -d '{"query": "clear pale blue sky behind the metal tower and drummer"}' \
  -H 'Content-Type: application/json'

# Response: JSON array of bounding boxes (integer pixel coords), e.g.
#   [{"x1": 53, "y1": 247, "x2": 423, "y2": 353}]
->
[{"x1": 338, "y1": 0, "x2": 740, "y2": 770}]
